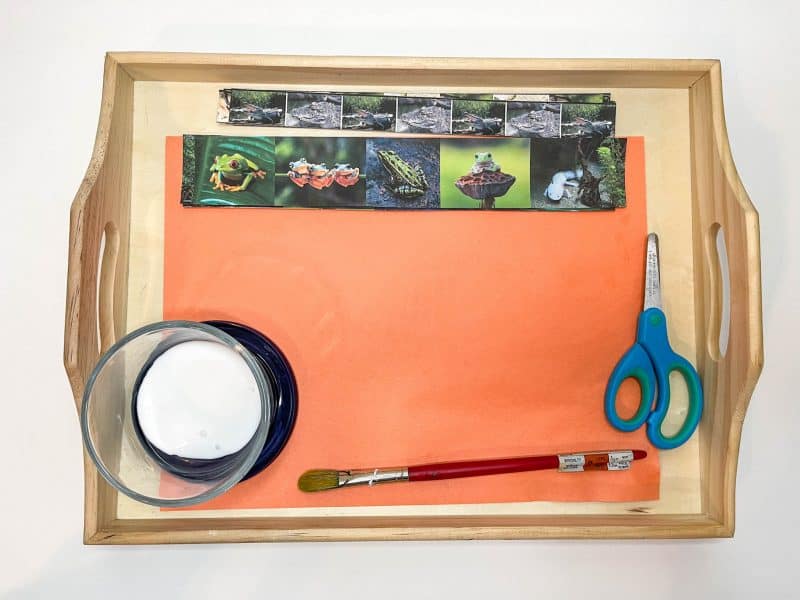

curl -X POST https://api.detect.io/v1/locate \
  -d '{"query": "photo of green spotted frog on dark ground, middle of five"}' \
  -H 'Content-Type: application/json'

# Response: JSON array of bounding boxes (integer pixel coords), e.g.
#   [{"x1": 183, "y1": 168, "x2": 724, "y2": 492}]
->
[{"x1": 367, "y1": 138, "x2": 439, "y2": 208}]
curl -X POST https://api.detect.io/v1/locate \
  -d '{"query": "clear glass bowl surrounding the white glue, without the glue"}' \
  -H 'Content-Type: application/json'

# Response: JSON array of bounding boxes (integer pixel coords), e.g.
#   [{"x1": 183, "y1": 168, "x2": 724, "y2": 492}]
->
[{"x1": 81, "y1": 321, "x2": 276, "y2": 507}]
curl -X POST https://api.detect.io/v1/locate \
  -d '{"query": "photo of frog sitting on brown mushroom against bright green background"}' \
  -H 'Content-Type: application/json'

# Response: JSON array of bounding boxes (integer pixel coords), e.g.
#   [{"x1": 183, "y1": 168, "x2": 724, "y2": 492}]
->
[{"x1": 441, "y1": 138, "x2": 530, "y2": 209}]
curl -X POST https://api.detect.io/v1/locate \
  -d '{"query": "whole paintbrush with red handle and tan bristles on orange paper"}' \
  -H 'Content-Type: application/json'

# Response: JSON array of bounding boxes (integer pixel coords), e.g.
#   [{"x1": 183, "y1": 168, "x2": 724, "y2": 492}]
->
[{"x1": 297, "y1": 450, "x2": 647, "y2": 492}]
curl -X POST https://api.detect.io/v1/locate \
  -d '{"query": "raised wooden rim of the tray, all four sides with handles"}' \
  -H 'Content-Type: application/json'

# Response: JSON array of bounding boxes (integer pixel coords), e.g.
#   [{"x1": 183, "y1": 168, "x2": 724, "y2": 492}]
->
[{"x1": 64, "y1": 52, "x2": 763, "y2": 543}]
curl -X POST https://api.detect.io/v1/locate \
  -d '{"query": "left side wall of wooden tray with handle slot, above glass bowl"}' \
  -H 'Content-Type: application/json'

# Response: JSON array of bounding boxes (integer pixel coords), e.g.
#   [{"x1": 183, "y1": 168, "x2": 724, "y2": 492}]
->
[{"x1": 64, "y1": 56, "x2": 133, "y2": 409}]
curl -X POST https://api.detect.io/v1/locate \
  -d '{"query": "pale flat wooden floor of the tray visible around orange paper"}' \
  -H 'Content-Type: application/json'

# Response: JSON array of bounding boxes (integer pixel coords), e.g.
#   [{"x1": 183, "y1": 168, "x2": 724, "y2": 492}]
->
[{"x1": 117, "y1": 81, "x2": 701, "y2": 519}]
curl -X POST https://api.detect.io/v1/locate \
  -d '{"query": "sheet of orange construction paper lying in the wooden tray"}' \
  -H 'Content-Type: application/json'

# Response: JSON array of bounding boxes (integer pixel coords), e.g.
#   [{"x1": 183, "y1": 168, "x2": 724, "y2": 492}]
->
[{"x1": 164, "y1": 137, "x2": 659, "y2": 509}]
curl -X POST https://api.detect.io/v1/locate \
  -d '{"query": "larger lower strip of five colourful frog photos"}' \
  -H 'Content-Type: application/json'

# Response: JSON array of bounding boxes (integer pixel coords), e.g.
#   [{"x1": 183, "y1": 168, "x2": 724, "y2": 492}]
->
[{"x1": 181, "y1": 134, "x2": 626, "y2": 211}]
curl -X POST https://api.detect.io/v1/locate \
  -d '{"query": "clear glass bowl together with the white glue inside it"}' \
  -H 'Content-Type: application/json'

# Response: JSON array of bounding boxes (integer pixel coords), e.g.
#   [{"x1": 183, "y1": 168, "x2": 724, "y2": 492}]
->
[{"x1": 81, "y1": 321, "x2": 275, "y2": 507}]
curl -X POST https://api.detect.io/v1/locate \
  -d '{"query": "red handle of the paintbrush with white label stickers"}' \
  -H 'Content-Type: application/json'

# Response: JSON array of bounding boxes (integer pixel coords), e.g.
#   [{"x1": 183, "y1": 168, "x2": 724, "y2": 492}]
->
[{"x1": 408, "y1": 450, "x2": 647, "y2": 481}]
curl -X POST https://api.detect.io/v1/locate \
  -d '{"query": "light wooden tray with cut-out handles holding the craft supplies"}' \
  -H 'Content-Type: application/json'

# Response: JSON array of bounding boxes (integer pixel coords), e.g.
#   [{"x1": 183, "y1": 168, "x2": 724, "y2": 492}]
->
[{"x1": 64, "y1": 53, "x2": 763, "y2": 544}]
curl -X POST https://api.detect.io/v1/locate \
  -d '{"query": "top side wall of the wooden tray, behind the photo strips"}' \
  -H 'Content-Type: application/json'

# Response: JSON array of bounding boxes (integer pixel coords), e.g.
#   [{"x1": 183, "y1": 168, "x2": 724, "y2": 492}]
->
[{"x1": 112, "y1": 52, "x2": 713, "y2": 91}]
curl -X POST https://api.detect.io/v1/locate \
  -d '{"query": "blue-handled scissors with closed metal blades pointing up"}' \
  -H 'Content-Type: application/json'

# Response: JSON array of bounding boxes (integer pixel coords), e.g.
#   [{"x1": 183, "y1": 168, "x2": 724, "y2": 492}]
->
[{"x1": 605, "y1": 233, "x2": 703, "y2": 450}]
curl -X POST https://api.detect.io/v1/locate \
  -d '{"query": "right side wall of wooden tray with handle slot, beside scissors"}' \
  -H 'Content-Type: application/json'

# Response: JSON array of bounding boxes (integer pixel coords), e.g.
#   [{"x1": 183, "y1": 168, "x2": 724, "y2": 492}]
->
[{"x1": 689, "y1": 62, "x2": 764, "y2": 535}]
